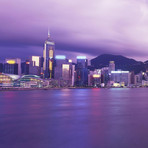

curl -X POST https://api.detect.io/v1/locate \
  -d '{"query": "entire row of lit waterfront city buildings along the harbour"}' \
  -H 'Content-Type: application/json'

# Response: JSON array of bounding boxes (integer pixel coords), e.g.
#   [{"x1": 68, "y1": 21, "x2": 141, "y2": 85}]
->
[{"x1": 0, "y1": 33, "x2": 148, "y2": 88}]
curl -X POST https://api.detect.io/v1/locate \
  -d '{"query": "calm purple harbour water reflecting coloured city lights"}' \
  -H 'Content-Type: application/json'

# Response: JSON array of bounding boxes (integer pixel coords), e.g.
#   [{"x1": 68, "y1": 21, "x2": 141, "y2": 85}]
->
[{"x1": 0, "y1": 88, "x2": 148, "y2": 148}]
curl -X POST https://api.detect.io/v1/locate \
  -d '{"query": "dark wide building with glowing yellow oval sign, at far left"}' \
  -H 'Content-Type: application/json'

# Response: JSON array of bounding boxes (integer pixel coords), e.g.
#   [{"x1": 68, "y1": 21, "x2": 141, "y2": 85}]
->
[{"x1": 4, "y1": 58, "x2": 21, "y2": 75}]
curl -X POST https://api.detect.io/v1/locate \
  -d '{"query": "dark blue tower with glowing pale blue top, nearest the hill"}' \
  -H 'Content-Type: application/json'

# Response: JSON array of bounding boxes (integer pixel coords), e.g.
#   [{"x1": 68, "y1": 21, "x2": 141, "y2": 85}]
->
[{"x1": 76, "y1": 56, "x2": 88, "y2": 87}]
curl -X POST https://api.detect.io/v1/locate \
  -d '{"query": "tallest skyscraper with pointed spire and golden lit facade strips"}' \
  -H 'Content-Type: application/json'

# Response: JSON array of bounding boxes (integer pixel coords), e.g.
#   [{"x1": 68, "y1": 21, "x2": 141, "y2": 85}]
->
[{"x1": 43, "y1": 31, "x2": 55, "y2": 79}]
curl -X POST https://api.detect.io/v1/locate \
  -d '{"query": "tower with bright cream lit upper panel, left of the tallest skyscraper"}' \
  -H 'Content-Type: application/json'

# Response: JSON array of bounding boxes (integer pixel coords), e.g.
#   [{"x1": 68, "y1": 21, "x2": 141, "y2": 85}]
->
[{"x1": 29, "y1": 56, "x2": 41, "y2": 76}]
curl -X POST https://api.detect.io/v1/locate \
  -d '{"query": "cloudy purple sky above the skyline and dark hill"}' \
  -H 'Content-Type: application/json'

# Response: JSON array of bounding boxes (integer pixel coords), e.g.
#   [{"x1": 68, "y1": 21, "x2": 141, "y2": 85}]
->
[{"x1": 0, "y1": 0, "x2": 148, "y2": 61}]
